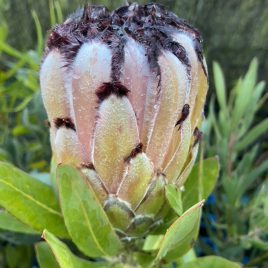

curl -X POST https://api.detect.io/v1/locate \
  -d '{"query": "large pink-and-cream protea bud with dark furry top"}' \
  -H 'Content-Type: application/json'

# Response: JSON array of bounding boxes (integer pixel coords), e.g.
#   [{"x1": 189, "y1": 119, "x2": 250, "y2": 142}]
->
[{"x1": 40, "y1": 3, "x2": 208, "y2": 235}]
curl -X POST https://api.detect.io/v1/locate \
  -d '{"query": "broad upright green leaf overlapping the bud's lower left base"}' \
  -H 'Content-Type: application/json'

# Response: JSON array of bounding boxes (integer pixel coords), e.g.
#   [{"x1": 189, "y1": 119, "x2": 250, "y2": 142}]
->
[{"x1": 57, "y1": 166, "x2": 121, "y2": 257}]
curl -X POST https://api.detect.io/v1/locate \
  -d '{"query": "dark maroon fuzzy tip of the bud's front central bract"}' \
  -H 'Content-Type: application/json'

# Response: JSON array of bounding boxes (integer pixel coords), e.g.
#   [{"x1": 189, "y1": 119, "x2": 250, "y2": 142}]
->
[{"x1": 96, "y1": 82, "x2": 129, "y2": 102}]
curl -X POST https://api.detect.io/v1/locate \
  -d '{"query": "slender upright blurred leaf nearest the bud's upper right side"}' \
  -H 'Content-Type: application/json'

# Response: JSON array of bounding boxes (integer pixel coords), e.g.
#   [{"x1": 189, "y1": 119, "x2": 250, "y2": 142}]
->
[{"x1": 213, "y1": 62, "x2": 228, "y2": 117}]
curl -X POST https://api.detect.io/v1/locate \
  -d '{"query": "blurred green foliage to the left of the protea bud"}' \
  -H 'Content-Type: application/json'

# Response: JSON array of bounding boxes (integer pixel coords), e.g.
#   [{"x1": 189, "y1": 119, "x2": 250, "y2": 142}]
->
[{"x1": 0, "y1": 2, "x2": 62, "y2": 171}]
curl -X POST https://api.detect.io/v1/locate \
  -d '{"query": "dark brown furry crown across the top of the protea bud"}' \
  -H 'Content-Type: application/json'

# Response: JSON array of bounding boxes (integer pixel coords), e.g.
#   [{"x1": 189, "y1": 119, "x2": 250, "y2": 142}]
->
[{"x1": 45, "y1": 3, "x2": 205, "y2": 73}]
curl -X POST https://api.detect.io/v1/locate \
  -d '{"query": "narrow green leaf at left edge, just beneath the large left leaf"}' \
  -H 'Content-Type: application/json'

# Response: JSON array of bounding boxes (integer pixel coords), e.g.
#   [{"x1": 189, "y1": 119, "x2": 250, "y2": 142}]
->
[{"x1": 0, "y1": 210, "x2": 38, "y2": 235}]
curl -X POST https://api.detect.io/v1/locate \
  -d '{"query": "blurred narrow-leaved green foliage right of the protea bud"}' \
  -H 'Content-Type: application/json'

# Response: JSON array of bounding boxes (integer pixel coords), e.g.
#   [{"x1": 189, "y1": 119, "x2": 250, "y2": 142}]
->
[{"x1": 203, "y1": 59, "x2": 268, "y2": 267}]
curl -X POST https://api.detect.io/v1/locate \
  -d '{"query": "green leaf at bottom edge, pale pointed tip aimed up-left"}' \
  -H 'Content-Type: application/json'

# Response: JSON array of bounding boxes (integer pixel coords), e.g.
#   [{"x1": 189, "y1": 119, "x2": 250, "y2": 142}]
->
[{"x1": 43, "y1": 230, "x2": 107, "y2": 268}]
